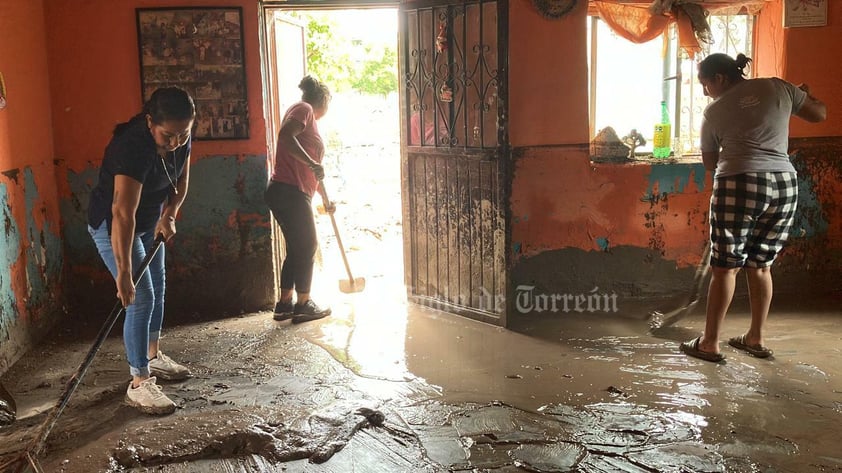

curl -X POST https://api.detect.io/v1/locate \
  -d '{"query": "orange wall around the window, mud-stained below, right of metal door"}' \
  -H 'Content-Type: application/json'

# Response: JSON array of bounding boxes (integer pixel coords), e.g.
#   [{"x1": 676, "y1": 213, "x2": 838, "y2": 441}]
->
[{"x1": 509, "y1": 0, "x2": 842, "y2": 295}]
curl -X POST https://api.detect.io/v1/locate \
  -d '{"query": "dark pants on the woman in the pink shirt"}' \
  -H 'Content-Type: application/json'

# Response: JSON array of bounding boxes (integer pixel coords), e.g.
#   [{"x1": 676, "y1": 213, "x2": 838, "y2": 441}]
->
[{"x1": 264, "y1": 181, "x2": 318, "y2": 293}]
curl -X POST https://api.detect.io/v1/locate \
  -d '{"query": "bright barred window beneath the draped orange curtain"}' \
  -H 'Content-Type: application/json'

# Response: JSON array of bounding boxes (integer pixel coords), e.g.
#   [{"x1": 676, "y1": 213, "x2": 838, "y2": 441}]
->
[{"x1": 588, "y1": 15, "x2": 754, "y2": 157}]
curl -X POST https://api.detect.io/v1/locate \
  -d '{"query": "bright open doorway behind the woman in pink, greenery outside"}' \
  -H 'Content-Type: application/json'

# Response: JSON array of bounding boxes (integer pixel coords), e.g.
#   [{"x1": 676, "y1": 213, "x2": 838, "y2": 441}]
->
[{"x1": 264, "y1": 7, "x2": 406, "y2": 306}]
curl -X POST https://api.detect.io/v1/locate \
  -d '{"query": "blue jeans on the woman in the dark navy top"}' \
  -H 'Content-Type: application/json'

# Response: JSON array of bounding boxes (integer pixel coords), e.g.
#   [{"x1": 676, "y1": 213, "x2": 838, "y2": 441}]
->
[{"x1": 88, "y1": 221, "x2": 166, "y2": 376}]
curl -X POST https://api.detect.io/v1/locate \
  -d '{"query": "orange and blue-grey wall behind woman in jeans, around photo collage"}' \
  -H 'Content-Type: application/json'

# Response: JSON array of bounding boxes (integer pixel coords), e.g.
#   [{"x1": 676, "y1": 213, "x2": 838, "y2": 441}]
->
[{"x1": 45, "y1": 0, "x2": 274, "y2": 317}]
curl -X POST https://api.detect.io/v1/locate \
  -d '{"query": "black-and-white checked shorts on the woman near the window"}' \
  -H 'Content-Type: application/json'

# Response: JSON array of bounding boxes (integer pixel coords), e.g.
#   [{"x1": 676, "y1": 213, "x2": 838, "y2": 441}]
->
[{"x1": 710, "y1": 172, "x2": 798, "y2": 268}]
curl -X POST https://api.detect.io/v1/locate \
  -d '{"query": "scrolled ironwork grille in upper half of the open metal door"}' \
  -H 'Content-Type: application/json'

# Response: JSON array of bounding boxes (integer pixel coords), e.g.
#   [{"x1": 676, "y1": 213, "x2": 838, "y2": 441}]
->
[{"x1": 405, "y1": 0, "x2": 499, "y2": 148}]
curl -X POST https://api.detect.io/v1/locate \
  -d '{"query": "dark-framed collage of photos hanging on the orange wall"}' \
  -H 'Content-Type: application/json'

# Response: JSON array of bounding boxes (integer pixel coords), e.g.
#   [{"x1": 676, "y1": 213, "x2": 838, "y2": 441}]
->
[{"x1": 135, "y1": 7, "x2": 249, "y2": 140}]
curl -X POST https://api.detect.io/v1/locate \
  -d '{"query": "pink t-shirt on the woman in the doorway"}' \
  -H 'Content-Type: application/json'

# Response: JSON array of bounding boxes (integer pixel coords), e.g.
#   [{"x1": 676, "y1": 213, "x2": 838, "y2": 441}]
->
[{"x1": 272, "y1": 102, "x2": 325, "y2": 197}]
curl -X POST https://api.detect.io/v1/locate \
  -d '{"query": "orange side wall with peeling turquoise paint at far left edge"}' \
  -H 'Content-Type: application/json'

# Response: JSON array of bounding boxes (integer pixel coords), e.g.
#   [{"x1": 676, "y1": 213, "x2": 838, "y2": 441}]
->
[{"x1": 0, "y1": 0, "x2": 62, "y2": 374}]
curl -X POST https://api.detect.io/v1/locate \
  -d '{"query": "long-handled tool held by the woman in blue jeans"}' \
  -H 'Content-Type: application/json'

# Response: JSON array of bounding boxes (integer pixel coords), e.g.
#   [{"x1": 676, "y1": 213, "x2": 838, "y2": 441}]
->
[{"x1": 0, "y1": 236, "x2": 164, "y2": 473}]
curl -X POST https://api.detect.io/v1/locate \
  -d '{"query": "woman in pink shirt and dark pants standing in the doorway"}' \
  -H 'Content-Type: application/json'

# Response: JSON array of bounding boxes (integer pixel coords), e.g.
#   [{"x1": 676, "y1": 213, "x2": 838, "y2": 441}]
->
[{"x1": 264, "y1": 76, "x2": 335, "y2": 323}]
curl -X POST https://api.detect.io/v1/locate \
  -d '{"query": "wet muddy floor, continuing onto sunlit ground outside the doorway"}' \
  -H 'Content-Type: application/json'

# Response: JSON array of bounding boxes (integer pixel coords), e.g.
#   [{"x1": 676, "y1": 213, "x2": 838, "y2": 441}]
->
[{"x1": 0, "y1": 105, "x2": 842, "y2": 473}]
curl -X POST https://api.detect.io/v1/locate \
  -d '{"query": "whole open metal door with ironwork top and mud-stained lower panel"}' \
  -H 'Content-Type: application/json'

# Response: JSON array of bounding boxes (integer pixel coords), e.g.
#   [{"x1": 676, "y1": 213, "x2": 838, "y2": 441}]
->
[{"x1": 399, "y1": 0, "x2": 509, "y2": 325}]
